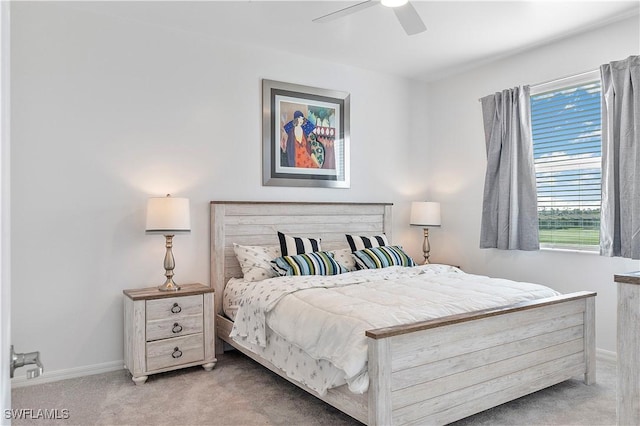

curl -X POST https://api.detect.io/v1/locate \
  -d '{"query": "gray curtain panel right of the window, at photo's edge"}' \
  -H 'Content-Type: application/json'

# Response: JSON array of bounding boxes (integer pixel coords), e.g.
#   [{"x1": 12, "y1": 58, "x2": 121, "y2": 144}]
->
[{"x1": 600, "y1": 56, "x2": 640, "y2": 259}]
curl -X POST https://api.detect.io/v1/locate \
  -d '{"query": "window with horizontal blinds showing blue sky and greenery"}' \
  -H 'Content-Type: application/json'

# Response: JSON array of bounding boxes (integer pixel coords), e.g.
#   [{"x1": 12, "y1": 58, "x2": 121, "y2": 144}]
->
[{"x1": 531, "y1": 71, "x2": 602, "y2": 251}]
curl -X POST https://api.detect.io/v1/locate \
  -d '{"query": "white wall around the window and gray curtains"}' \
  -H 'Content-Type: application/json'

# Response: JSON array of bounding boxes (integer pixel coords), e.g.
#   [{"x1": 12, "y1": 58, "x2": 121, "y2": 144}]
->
[{"x1": 425, "y1": 16, "x2": 640, "y2": 351}]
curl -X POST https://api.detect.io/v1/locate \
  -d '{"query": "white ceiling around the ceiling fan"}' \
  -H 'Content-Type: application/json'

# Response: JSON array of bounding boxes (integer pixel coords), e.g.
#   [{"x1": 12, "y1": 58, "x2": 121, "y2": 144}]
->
[{"x1": 67, "y1": 0, "x2": 640, "y2": 81}]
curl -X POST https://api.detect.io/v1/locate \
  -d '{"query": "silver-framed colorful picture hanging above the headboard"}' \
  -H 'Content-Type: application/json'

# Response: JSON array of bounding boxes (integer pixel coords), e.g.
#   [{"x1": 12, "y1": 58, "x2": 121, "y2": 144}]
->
[{"x1": 262, "y1": 80, "x2": 349, "y2": 188}]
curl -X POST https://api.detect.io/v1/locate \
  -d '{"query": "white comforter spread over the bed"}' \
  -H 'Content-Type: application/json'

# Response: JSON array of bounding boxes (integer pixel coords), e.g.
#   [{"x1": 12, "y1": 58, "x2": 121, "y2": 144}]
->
[{"x1": 231, "y1": 265, "x2": 559, "y2": 394}]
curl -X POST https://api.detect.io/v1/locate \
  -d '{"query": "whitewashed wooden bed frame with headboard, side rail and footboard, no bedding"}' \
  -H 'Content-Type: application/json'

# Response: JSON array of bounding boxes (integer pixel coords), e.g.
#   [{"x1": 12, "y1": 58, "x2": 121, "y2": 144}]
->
[{"x1": 210, "y1": 201, "x2": 596, "y2": 425}]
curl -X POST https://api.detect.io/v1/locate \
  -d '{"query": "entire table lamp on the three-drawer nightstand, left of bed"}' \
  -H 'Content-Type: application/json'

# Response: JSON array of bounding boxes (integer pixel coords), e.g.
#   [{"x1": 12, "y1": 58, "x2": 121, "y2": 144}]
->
[{"x1": 146, "y1": 194, "x2": 191, "y2": 291}]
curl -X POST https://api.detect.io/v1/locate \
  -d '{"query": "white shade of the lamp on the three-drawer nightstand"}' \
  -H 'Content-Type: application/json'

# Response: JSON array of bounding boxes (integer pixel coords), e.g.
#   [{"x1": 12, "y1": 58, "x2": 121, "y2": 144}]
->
[{"x1": 146, "y1": 194, "x2": 191, "y2": 235}]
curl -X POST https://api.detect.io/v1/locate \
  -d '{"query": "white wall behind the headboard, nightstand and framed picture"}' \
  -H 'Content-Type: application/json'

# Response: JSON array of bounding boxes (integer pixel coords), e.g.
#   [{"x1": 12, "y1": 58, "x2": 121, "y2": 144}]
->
[{"x1": 11, "y1": 2, "x2": 425, "y2": 374}]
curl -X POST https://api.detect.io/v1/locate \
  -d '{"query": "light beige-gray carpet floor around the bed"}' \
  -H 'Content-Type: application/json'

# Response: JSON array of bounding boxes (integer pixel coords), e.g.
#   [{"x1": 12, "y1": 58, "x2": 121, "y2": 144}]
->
[{"x1": 12, "y1": 352, "x2": 616, "y2": 426}]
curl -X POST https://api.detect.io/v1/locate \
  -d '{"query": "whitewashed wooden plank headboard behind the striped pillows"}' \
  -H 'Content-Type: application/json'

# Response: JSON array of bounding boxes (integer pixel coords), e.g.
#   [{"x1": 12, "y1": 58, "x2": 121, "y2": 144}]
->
[{"x1": 210, "y1": 201, "x2": 392, "y2": 314}]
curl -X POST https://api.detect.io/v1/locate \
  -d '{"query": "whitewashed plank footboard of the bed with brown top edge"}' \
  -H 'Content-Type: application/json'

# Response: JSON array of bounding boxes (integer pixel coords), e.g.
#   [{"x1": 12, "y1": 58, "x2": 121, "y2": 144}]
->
[{"x1": 367, "y1": 292, "x2": 596, "y2": 425}]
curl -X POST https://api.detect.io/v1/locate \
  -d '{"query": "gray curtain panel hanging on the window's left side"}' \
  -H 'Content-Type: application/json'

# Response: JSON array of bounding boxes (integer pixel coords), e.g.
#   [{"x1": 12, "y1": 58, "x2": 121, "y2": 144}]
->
[{"x1": 480, "y1": 86, "x2": 540, "y2": 250}]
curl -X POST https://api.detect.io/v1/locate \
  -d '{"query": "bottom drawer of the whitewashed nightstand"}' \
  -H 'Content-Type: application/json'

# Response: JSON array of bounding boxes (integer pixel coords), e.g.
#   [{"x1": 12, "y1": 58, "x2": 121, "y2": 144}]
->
[{"x1": 147, "y1": 333, "x2": 204, "y2": 371}]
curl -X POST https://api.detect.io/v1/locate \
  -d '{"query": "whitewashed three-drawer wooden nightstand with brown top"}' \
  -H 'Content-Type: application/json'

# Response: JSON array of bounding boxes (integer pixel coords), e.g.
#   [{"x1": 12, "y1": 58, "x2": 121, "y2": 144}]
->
[{"x1": 123, "y1": 284, "x2": 217, "y2": 385}]
